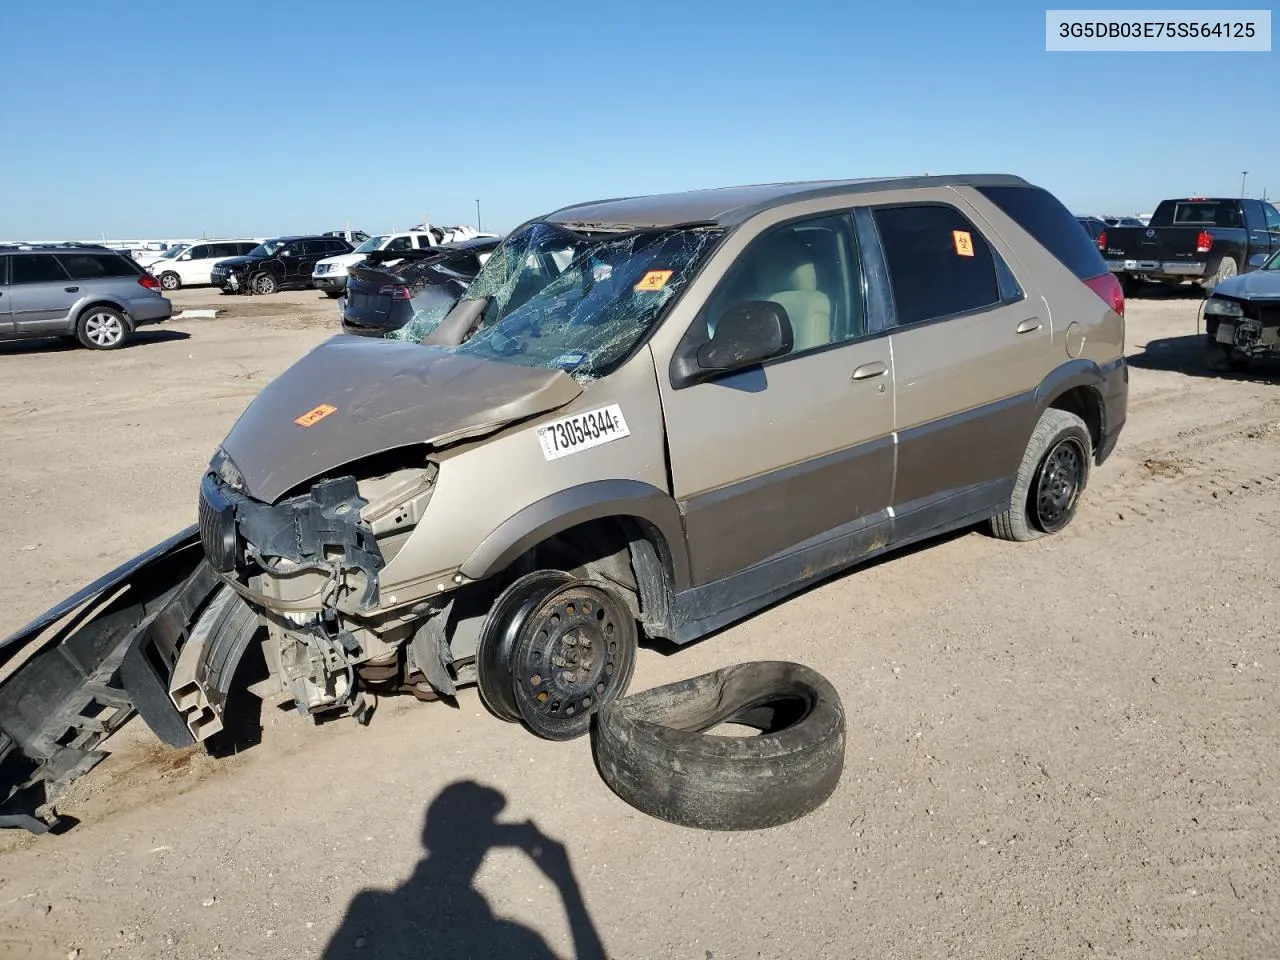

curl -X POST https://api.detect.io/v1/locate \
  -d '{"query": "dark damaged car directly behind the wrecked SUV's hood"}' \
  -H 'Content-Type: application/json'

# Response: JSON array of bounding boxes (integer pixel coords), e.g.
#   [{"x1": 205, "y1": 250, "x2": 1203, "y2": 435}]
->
[{"x1": 342, "y1": 237, "x2": 499, "y2": 339}]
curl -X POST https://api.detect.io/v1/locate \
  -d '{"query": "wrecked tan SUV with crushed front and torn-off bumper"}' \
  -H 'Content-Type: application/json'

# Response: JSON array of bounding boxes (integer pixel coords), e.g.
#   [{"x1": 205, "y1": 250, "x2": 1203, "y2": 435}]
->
[{"x1": 0, "y1": 175, "x2": 1128, "y2": 829}]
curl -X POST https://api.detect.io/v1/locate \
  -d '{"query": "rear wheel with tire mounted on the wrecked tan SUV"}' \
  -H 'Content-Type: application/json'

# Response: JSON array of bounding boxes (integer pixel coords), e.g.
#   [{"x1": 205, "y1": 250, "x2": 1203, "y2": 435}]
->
[{"x1": 991, "y1": 408, "x2": 1093, "y2": 541}]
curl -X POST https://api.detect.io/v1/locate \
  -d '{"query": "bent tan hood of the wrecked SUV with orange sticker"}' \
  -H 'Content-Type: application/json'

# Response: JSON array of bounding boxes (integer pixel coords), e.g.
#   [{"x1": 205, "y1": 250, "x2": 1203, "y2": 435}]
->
[{"x1": 223, "y1": 334, "x2": 582, "y2": 503}]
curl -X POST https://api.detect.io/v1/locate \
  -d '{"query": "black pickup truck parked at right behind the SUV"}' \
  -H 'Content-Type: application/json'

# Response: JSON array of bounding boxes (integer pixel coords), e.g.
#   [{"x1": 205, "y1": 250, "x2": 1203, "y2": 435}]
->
[{"x1": 1098, "y1": 197, "x2": 1280, "y2": 291}]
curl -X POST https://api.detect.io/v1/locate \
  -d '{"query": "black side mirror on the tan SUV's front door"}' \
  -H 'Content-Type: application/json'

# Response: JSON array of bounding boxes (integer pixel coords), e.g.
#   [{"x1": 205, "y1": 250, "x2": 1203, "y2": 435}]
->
[{"x1": 672, "y1": 300, "x2": 795, "y2": 388}]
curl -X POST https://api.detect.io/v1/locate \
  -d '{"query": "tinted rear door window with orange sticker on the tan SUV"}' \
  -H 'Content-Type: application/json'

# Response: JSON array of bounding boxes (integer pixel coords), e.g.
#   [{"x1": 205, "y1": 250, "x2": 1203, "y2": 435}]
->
[{"x1": 873, "y1": 204, "x2": 1003, "y2": 326}]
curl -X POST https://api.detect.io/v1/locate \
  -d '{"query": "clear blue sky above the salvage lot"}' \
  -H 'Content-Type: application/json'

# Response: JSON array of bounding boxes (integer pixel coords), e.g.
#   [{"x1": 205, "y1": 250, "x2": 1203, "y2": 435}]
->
[{"x1": 0, "y1": 0, "x2": 1280, "y2": 239}]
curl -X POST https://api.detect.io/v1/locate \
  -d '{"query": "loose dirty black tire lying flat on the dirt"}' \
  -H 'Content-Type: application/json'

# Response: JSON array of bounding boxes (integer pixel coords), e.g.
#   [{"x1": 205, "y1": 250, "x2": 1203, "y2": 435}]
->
[{"x1": 591, "y1": 660, "x2": 845, "y2": 831}]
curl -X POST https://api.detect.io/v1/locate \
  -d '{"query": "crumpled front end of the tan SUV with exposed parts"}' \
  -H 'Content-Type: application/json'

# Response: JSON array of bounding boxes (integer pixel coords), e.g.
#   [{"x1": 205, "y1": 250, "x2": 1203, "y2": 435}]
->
[{"x1": 188, "y1": 453, "x2": 450, "y2": 737}]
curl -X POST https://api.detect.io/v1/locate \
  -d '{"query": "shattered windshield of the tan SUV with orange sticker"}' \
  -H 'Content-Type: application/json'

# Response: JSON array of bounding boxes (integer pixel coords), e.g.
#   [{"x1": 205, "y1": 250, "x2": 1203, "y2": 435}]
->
[{"x1": 440, "y1": 223, "x2": 723, "y2": 378}]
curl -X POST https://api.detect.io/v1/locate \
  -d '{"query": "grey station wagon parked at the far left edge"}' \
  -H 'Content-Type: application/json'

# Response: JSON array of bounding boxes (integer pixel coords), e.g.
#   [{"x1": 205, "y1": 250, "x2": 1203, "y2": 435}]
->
[{"x1": 0, "y1": 243, "x2": 173, "y2": 350}]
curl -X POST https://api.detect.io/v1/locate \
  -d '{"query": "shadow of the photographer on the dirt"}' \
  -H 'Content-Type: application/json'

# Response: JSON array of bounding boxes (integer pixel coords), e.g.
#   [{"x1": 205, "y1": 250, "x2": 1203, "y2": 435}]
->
[{"x1": 323, "y1": 781, "x2": 605, "y2": 960}]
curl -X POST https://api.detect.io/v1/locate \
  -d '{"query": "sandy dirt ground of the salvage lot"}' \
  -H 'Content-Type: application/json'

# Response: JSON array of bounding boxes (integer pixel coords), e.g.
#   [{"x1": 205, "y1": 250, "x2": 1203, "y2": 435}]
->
[{"x1": 0, "y1": 291, "x2": 1280, "y2": 960}]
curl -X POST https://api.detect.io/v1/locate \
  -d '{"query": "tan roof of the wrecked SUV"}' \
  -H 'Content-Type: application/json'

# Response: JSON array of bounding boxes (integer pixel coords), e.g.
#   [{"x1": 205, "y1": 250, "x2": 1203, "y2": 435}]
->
[{"x1": 543, "y1": 174, "x2": 1030, "y2": 227}]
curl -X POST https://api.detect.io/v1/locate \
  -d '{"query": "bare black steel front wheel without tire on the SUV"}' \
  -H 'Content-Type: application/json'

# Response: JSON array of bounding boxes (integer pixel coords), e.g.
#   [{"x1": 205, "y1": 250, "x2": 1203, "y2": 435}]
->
[{"x1": 511, "y1": 580, "x2": 639, "y2": 740}]
